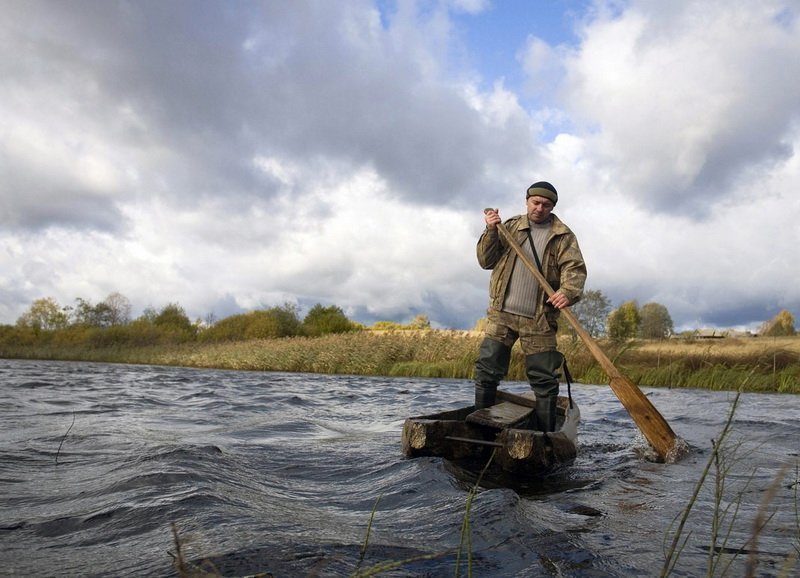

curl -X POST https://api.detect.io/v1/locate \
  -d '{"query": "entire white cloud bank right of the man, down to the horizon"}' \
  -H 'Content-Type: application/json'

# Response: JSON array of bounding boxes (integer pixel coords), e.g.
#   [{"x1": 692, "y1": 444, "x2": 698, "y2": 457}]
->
[{"x1": 522, "y1": 1, "x2": 800, "y2": 328}]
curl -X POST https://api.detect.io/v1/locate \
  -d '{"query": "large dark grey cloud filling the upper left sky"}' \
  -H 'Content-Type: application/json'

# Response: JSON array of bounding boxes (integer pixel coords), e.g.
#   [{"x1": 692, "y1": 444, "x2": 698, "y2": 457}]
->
[{"x1": 0, "y1": 0, "x2": 532, "y2": 234}]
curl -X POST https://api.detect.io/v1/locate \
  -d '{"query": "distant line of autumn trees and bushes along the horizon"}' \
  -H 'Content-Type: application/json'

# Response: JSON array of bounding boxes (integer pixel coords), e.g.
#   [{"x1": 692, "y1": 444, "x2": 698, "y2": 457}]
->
[{"x1": 0, "y1": 289, "x2": 796, "y2": 347}]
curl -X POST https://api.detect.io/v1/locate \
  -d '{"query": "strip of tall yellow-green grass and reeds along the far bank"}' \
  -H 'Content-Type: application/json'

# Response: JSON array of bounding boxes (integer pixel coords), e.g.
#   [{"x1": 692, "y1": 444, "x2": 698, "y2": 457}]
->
[{"x1": 0, "y1": 330, "x2": 800, "y2": 393}]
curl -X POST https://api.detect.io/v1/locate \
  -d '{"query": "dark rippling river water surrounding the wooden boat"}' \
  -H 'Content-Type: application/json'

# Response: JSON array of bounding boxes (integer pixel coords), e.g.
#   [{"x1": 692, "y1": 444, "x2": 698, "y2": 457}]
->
[{"x1": 0, "y1": 360, "x2": 800, "y2": 577}]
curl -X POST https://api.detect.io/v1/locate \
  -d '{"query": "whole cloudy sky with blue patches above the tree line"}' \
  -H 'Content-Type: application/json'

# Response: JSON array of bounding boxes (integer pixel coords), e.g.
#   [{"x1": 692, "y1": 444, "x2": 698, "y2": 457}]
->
[{"x1": 0, "y1": 0, "x2": 800, "y2": 329}]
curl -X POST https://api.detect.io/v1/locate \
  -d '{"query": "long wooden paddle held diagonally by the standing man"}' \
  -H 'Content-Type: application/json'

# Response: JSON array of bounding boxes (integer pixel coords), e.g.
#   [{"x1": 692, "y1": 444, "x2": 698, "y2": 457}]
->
[{"x1": 497, "y1": 223, "x2": 679, "y2": 461}]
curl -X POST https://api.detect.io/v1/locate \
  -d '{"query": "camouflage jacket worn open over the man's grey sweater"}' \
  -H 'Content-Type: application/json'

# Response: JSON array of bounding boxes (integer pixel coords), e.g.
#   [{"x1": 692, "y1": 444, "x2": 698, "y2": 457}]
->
[{"x1": 477, "y1": 215, "x2": 586, "y2": 326}]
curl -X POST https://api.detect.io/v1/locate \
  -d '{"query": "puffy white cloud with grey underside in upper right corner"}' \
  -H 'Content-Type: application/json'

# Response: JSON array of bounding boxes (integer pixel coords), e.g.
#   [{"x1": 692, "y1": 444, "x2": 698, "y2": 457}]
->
[{"x1": 562, "y1": 1, "x2": 800, "y2": 218}]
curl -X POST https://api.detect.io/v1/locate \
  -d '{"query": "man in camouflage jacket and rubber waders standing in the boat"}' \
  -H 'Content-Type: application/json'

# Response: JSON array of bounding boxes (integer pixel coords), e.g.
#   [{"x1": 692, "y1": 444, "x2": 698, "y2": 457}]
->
[{"x1": 475, "y1": 181, "x2": 586, "y2": 431}]
